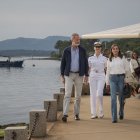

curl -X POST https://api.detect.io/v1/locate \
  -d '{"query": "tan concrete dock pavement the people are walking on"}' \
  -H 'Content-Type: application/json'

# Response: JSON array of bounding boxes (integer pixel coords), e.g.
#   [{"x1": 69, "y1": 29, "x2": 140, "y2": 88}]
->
[{"x1": 32, "y1": 96, "x2": 140, "y2": 140}]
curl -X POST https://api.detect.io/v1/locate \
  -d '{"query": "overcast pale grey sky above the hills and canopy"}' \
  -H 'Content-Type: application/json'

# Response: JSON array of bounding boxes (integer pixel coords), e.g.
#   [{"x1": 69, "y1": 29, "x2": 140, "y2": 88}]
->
[{"x1": 0, "y1": 0, "x2": 140, "y2": 41}]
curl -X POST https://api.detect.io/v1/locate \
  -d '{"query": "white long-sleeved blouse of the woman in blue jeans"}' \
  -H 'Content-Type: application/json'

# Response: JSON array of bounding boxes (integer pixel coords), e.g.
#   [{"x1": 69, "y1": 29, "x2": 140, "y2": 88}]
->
[{"x1": 106, "y1": 57, "x2": 127, "y2": 85}]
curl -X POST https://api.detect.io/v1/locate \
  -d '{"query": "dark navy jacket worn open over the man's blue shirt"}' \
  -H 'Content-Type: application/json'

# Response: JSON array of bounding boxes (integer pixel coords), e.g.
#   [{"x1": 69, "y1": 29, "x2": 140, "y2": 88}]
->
[{"x1": 61, "y1": 46, "x2": 88, "y2": 76}]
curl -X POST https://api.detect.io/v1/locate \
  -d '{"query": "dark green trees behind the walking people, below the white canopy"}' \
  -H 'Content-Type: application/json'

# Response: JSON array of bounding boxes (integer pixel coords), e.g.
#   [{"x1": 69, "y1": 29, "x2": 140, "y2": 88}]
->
[{"x1": 51, "y1": 38, "x2": 140, "y2": 58}]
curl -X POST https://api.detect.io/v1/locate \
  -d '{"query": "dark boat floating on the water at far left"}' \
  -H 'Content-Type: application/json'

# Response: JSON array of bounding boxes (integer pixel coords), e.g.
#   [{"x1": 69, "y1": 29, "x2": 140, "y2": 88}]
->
[{"x1": 0, "y1": 58, "x2": 24, "y2": 67}]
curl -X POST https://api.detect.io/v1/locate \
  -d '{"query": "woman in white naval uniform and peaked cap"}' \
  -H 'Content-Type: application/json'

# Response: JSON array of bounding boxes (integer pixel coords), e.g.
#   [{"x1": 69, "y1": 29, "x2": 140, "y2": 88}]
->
[{"x1": 88, "y1": 42, "x2": 107, "y2": 119}]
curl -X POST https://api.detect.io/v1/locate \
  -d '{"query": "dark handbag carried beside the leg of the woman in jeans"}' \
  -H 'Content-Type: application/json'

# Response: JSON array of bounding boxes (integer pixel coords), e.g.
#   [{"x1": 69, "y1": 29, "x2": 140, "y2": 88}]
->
[{"x1": 123, "y1": 84, "x2": 133, "y2": 99}]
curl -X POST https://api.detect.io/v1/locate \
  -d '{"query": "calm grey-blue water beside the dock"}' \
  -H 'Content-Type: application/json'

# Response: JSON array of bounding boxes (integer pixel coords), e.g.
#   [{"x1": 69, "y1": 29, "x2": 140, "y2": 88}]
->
[{"x1": 0, "y1": 60, "x2": 62, "y2": 125}]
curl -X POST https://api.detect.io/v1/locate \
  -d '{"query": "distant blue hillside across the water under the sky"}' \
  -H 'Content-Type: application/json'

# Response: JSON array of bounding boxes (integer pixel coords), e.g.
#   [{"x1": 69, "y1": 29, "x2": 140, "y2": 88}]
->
[{"x1": 0, "y1": 36, "x2": 70, "y2": 51}]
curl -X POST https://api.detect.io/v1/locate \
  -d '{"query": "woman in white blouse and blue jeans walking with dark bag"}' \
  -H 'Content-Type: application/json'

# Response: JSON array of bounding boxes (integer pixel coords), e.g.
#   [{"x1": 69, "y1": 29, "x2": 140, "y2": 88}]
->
[{"x1": 106, "y1": 44, "x2": 126, "y2": 123}]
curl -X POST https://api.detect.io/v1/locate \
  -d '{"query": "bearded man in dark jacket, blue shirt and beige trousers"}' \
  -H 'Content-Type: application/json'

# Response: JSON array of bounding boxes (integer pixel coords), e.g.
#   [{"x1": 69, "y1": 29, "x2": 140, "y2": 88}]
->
[{"x1": 61, "y1": 33, "x2": 88, "y2": 122}]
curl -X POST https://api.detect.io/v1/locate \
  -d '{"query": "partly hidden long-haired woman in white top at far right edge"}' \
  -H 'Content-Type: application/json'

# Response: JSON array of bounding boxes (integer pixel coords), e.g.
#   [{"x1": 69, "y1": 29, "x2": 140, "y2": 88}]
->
[{"x1": 130, "y1": 51, "x2": 140, "y2": 93}]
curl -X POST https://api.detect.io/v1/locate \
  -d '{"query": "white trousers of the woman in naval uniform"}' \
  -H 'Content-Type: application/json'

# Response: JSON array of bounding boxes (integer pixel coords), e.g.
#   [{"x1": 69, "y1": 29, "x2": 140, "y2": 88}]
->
[{"x1": 89, "y1": 73, "x2": 105, "y2": 116}]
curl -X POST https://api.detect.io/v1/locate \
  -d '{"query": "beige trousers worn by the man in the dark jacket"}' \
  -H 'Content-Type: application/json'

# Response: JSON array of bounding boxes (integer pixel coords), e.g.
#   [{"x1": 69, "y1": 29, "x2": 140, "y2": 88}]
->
[{"x1": 63, "y1": 73, "x2": 83, "y2": 115}]
